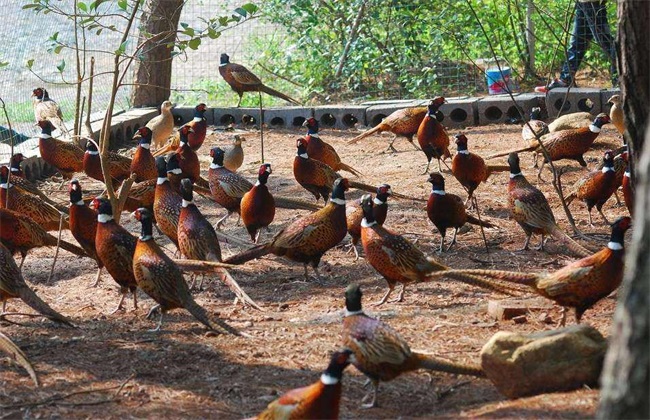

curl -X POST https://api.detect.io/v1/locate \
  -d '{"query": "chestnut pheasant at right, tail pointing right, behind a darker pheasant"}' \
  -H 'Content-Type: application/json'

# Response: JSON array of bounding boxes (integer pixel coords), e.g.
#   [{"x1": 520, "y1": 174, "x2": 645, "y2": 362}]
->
[{"x1": 451, "y1": 134, "x2": 509, "y2": 205}]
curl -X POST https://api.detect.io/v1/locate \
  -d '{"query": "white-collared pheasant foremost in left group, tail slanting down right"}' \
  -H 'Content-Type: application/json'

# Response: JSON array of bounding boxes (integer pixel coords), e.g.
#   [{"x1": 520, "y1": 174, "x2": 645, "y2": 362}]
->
[{"x1": 132, "y1": 208, "x2": 239, "y2": 335}]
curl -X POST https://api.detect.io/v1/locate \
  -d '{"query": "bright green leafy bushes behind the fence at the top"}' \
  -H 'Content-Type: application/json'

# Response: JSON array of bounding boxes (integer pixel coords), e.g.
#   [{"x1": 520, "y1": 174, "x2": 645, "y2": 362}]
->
[{"x1": 260, "y1": 0, "x2": 616, "y2": 98}]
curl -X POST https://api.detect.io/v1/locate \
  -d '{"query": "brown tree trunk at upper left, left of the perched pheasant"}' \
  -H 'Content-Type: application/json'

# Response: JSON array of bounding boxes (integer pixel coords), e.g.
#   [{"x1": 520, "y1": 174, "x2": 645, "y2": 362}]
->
[{"x1": 131, "y1": 0, "x2": 184, "y2": 108}]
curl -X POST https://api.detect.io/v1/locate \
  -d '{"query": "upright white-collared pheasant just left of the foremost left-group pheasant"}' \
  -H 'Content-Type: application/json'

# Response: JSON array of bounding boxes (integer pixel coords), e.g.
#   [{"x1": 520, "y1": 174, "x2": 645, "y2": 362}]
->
[{"x1": 91, "y1": 198, "x2": 138, "y2": 314}]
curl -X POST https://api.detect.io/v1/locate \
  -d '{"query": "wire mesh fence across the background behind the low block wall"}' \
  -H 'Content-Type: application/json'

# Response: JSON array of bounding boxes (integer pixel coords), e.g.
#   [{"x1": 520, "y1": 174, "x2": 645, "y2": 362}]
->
[{"x1": 0, "y1": 0, "x2": 615, "y2": 161}]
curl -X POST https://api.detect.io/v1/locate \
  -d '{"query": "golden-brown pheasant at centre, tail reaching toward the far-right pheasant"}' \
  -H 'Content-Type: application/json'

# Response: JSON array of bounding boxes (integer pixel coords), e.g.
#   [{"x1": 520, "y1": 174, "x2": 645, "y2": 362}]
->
[{"x1": 361, "y1": 194, "x2": 509, "y2": 306}]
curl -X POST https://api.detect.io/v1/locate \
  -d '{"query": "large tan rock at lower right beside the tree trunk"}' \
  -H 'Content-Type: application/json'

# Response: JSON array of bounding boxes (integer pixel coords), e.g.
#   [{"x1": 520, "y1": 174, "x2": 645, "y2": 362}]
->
[{"x1": 481, "y1": 325, "x2": 607, "y2": 398}]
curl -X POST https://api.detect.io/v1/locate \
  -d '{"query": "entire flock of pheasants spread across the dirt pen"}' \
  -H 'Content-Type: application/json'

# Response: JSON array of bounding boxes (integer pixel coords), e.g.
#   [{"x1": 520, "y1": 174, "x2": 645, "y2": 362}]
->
[{"x1": 0, "y1": 77, "x2": 634, "y2": 418}]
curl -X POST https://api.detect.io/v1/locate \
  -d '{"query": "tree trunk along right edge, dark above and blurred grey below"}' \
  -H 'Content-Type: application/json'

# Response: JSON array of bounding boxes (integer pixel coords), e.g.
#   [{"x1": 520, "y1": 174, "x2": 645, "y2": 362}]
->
[{"x1": 598, "y1": 0, "x2": 650, "y2": 419}]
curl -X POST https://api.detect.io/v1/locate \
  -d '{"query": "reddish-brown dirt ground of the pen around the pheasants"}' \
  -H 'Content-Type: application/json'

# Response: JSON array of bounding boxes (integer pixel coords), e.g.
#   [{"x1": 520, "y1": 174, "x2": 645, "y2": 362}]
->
[{"x1": 0, "y1": 117, "x2": 630, "y2": 418}]
